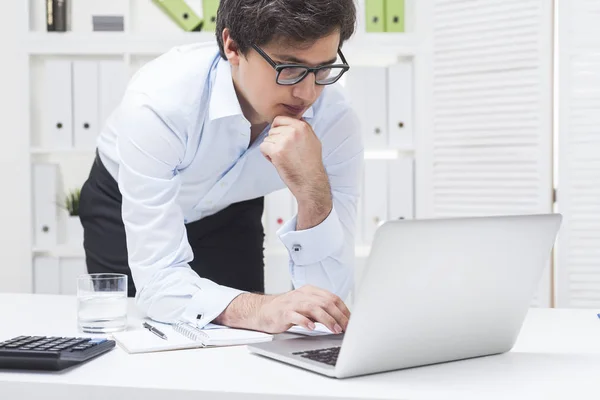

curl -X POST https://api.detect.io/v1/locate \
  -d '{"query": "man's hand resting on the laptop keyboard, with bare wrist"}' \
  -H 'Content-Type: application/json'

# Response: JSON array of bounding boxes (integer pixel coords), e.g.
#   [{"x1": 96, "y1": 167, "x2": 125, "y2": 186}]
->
[{"x1": 215, "y1": 285, "x2": 350, "y2": 333}]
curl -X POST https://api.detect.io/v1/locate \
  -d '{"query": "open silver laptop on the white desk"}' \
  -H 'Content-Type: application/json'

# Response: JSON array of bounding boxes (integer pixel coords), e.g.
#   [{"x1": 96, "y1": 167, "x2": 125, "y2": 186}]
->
[{"x1": 248, "y1": 214, "x2": 562, "y2": 378}]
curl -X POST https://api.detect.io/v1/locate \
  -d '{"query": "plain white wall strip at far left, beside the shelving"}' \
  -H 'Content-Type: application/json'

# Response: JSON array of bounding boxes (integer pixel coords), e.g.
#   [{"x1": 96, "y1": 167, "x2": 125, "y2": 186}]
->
[{"x1": 0, "y1": 0, "x2": 31, "y2": 292}]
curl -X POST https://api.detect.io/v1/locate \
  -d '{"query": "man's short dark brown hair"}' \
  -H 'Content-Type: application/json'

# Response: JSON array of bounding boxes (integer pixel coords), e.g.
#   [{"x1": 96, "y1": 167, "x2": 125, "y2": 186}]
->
[{"x1": 216, "y1": 0, "x2": 356, "y2": 59}]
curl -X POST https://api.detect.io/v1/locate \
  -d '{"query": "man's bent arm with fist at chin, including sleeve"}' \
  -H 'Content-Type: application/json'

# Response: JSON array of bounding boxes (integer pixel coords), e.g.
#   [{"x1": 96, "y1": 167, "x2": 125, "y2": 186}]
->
[{"x1": 261, "y1": 107, "x2": 364, "y2": 299}]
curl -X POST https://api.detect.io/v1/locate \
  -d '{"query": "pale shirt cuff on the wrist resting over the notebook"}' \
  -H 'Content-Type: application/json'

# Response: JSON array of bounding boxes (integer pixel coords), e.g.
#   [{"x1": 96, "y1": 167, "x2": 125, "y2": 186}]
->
[{"x1": 182, "y1": 283, "x2": 245, "y2": 328}]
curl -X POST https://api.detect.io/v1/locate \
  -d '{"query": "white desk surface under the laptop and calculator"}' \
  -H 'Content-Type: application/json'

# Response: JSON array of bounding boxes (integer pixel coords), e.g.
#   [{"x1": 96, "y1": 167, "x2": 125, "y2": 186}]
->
[{"x1": 0, "y1": 294, "x2": 600, "y2": 400}]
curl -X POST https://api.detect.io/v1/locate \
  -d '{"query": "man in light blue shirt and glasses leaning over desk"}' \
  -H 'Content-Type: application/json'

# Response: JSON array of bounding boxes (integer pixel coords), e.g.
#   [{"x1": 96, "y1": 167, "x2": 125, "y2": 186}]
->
[{"x1": 80, "y1": 0, "x2": 363, "y2": 333}]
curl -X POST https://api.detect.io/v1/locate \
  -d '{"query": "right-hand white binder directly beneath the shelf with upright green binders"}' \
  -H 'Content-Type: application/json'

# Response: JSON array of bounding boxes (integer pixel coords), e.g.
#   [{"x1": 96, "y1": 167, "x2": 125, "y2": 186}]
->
[{"x1": 387, "y1": 61, "x2": 414, "y2": 148}]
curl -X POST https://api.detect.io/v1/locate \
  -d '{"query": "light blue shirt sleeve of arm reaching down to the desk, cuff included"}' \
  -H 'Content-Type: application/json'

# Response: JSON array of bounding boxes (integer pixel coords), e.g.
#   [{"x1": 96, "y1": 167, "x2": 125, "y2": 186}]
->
[{"x1": 111, "y1": 92, "x2": 242, "y2": 323}]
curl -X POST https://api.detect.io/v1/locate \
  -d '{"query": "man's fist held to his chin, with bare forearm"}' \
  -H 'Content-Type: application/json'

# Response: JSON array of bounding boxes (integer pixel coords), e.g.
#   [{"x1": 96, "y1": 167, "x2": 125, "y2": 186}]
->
[{"x1": 260, "y1": 117, "x2": 333, "y2": 230}]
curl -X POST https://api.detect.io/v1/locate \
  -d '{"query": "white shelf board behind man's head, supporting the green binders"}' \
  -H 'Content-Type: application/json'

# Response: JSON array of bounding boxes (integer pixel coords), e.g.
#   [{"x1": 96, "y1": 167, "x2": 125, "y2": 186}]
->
[{"x1": 25, "y1": 31, "x2": 418, "y2": 58}]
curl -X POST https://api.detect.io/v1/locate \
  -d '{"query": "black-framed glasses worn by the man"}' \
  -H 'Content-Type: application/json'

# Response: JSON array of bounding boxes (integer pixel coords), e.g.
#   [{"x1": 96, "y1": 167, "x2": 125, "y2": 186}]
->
[{"x1": 252, "y1": 45, "x2": 350, "y2": 85}]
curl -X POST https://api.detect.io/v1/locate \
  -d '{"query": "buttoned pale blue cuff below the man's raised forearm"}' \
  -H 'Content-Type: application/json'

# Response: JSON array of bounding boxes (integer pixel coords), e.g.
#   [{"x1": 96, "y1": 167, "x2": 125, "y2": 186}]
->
[{"x1": 277, "y1": 208, "x2": 344, "y2": 266}]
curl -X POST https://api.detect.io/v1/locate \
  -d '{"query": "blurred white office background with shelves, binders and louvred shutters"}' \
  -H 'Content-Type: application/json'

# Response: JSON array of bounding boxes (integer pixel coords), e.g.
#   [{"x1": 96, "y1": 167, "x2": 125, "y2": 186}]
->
[{"x1": 0, "y1": 0, "x2": 600, "y2": 308}]
